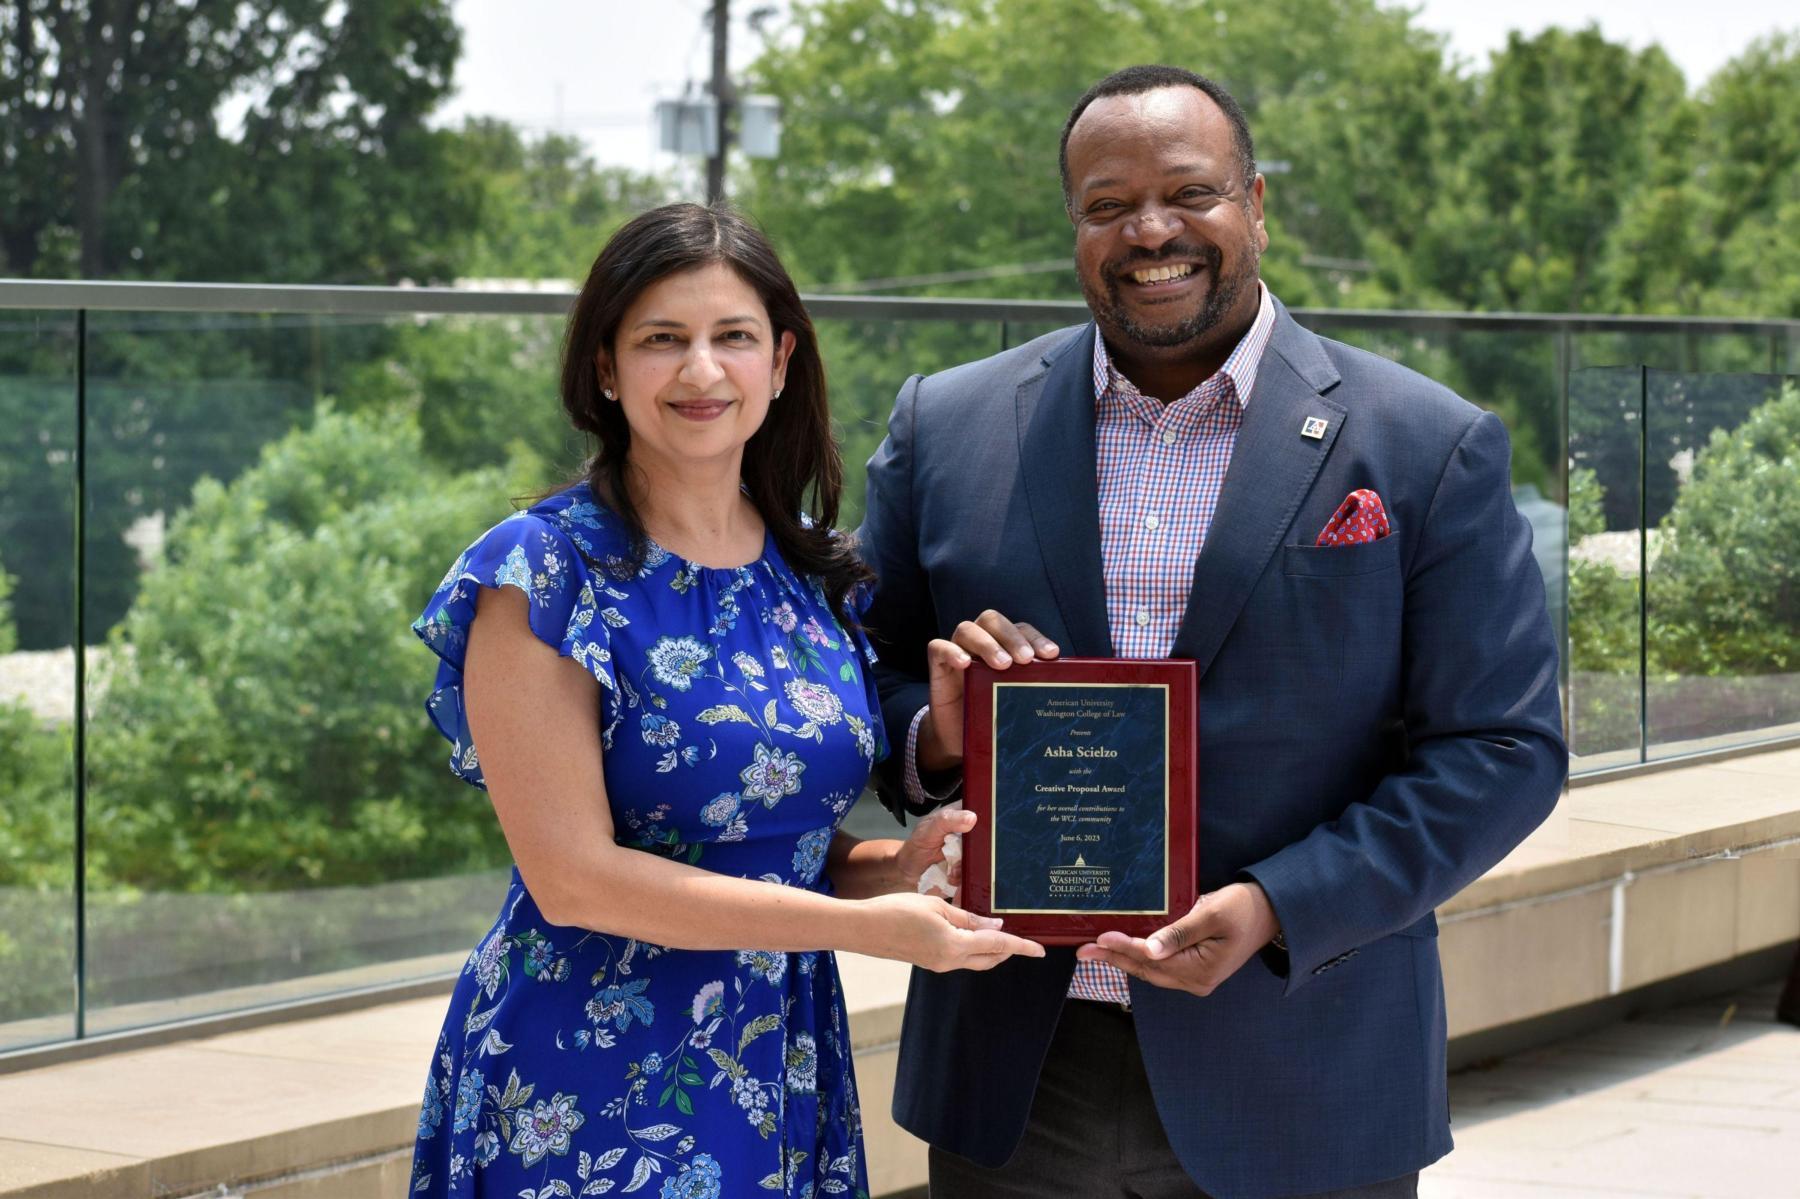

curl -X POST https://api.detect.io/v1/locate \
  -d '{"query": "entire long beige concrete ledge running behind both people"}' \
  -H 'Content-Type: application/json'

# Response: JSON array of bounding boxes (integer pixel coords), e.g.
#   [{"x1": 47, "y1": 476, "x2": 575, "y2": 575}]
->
[{"x1": 0, "y1": 749, "x2": 1800, "y2": 1199}]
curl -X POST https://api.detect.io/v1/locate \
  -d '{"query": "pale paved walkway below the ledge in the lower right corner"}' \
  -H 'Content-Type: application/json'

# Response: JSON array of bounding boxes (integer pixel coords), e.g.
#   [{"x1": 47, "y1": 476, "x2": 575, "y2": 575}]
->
[{"x1": 1418, "y1": 985, "x2": 1800, "y2": 1199}]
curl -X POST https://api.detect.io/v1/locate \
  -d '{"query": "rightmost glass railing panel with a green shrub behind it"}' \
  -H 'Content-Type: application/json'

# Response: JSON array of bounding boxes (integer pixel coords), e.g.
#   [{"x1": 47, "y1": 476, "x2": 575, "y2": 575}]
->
[{"x1": 1645, "y1": 371, "x2": 1800, "y2": 758}]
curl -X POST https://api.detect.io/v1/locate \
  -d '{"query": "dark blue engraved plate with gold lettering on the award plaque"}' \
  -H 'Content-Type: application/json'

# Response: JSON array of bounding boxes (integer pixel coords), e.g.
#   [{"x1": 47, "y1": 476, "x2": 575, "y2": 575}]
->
[{"x1": 988, "y1": 672, "x2": 1170, "y2": 915}]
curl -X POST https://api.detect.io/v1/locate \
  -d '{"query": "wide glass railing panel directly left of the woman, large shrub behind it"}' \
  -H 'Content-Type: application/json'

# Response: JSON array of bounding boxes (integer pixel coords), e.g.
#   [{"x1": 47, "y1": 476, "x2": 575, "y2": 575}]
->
[{"x1": 86, "y1": 307, "x2": 565, "y2": 1032}]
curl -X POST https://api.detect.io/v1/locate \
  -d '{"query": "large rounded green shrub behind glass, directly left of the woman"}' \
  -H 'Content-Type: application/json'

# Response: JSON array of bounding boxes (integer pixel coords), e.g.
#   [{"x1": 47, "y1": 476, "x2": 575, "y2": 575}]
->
[{"x1": 88, "y1": 409, "x2": 511, "y2": 891}]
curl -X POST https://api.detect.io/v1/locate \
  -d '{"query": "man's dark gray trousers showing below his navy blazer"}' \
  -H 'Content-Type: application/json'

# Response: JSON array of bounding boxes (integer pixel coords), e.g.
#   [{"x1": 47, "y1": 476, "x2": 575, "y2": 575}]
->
[{"x1": 931, "y1": 999, "x2": 1418, "y2": 1199}]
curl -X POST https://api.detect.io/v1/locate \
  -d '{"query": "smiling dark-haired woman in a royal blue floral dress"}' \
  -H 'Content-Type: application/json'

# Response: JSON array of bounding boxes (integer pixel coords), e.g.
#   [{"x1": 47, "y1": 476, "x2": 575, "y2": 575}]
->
[{"x1": 401, "y1": 205, "x2": 1042, "y2": 1199}]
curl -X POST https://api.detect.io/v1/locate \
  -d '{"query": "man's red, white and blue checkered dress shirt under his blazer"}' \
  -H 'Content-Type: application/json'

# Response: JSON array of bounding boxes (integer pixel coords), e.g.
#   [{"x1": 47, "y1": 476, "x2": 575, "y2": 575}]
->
[{"x1": 904, "y1": 284, "x2": 1274, "y2": 1003}]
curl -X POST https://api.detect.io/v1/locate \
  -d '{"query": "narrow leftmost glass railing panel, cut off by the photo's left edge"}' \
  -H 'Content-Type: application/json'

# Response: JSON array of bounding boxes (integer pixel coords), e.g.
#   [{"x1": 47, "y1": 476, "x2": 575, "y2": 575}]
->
[{"x1": 0, "y1": 310, "x2": 77, "y2": 1050}]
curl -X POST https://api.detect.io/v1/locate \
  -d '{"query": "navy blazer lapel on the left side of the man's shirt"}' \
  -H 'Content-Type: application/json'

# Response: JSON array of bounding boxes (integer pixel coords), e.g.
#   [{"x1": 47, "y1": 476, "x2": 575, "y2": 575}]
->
[{"x1": 1017, "y1": 324, "x2": 1112, "y2": 657}]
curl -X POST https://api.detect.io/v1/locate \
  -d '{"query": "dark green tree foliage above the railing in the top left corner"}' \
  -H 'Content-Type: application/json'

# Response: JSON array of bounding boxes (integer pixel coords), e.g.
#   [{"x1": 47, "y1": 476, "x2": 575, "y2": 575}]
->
[{"x1": 0, "y1": 0, "x2": 479, "y2": 283}]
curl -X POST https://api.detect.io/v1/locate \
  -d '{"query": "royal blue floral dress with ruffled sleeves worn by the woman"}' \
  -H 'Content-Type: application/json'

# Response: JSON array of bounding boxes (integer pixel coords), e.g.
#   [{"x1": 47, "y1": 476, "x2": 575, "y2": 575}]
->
[{"x1": 412, "y1": 484, "x2": 886, "y2": 1199}]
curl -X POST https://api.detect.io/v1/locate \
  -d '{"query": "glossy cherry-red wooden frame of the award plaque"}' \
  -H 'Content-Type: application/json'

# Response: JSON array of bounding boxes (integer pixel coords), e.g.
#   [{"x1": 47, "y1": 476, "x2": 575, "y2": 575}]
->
[{"x1": 959, "y1": 657, "x2": 1199, "y2": 945}]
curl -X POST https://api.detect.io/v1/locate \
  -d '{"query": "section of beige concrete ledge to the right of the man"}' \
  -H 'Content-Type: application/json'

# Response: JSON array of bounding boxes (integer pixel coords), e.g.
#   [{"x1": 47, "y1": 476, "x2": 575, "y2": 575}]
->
[{"x1": 1438, "y1": 749, "x2": 1800, "y2": 1039}]
